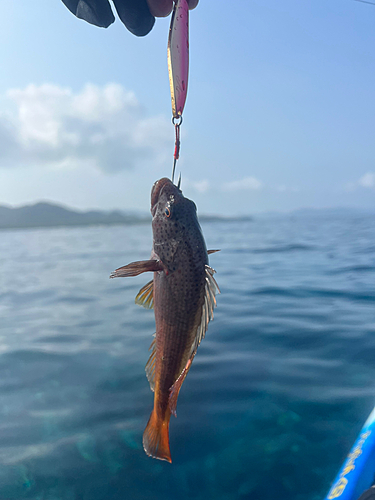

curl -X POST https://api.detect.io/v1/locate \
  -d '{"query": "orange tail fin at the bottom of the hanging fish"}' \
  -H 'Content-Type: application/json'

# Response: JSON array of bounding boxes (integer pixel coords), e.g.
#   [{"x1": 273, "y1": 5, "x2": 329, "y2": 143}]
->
[{"x1": 143, "y1": 410, "x2": 172, "y2": 463}]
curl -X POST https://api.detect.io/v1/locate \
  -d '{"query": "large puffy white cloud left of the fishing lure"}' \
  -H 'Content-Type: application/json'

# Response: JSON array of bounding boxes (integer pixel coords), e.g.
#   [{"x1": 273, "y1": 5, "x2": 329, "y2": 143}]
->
[{"x1": 0, "y1": 83, "x2": 172, "y2": 172}]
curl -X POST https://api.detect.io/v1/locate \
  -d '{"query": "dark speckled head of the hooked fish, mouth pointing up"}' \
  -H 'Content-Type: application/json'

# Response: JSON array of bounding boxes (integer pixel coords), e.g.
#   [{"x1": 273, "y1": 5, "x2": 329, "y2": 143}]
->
[{"x1": 151, "y1": 178, "x2": 206, "y2": 267}]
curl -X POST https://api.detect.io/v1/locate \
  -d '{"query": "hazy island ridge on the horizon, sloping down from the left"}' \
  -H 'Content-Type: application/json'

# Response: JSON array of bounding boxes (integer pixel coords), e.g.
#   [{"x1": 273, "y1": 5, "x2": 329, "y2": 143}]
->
[{"x1": 0, "y1": 202, "x2": 252, "y2": 229}]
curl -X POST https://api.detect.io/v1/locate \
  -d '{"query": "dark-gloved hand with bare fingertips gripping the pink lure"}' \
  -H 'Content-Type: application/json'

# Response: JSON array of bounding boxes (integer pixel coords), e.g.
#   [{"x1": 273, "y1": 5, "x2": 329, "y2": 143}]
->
[{"x1": 62, "y1": 0, "x2": 199, "y2": 36}]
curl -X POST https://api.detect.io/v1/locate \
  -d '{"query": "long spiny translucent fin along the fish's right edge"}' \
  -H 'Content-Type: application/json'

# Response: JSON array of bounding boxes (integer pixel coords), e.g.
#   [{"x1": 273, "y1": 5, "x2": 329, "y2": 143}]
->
[{"x1": 169, "y1": 265, "x2": 220, "y2": 416}]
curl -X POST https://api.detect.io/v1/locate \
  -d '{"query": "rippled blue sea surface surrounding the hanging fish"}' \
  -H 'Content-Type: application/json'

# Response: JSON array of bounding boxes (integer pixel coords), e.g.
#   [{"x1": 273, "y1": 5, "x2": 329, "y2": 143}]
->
[{"x1": 0, "y1": 213, "x2": 375, "y2": 500}]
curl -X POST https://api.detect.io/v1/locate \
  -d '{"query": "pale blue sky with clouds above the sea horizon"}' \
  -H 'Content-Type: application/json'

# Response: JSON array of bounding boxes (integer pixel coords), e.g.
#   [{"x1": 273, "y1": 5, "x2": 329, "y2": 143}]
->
[{"x1": 0, "y1": 0, "x2": 375, "y2": 215}]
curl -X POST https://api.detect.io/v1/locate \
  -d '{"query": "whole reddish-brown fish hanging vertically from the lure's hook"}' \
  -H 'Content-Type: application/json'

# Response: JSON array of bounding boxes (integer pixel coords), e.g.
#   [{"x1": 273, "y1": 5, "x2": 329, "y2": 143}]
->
[{"x1": 110, "y1": 178, "x2": 220, "y2": 463}]
